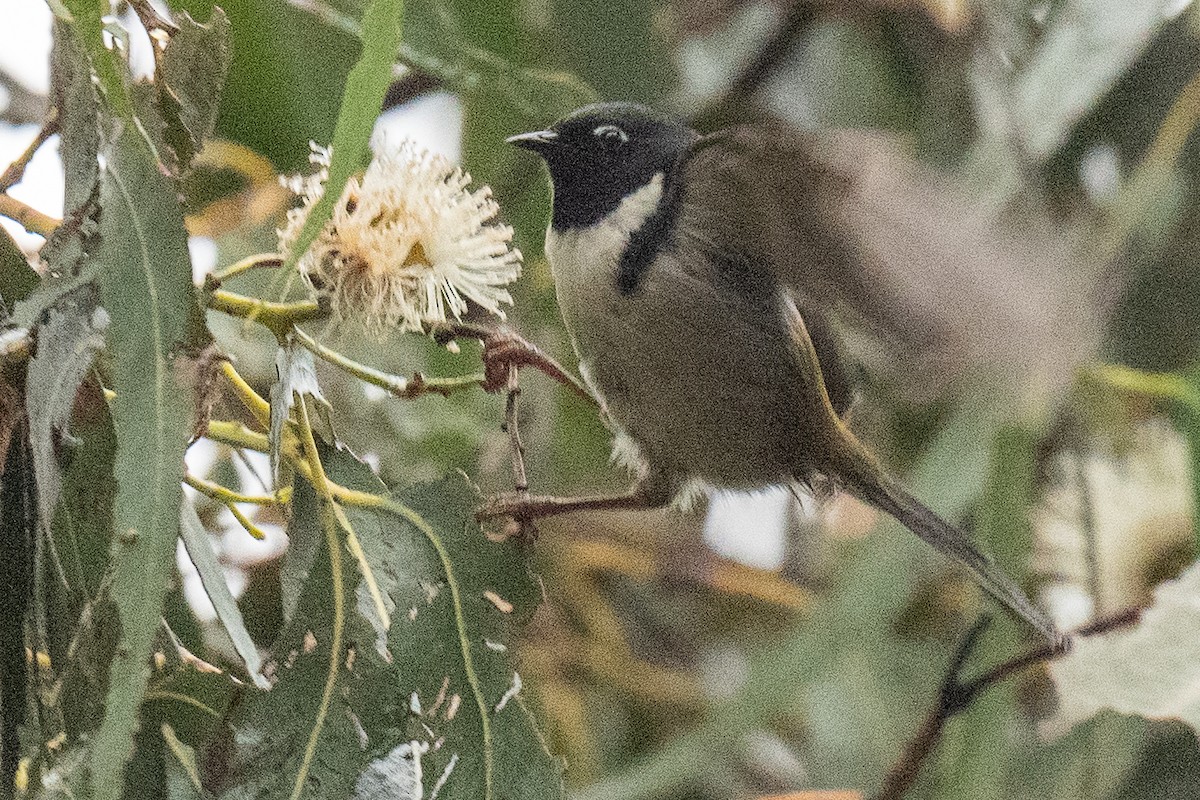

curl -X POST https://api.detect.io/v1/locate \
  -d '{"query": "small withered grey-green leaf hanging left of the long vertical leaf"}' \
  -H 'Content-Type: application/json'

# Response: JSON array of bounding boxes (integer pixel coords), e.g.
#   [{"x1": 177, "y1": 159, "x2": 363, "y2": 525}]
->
[{"x1": 25, "y1": 287, "x2": 108, "y2": 542}]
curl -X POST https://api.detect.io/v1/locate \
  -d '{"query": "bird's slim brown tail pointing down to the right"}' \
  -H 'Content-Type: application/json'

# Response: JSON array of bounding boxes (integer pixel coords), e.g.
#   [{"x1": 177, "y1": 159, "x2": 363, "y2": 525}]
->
[{"x1": 838, "y1": 450, "x2": 1062, "y2": 646}]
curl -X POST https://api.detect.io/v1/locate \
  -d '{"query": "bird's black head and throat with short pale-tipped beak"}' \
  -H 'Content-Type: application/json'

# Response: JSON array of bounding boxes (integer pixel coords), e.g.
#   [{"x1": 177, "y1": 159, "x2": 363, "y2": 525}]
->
[{"x1": 509, "y1": 103, "x2": 698, "y2": 230}]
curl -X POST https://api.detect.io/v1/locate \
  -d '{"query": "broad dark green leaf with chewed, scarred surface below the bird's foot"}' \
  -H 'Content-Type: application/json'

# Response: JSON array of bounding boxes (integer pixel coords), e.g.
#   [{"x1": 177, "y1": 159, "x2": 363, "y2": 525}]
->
[{"x1": 220, "y1": 451, "x2": 562, "y2": 800}]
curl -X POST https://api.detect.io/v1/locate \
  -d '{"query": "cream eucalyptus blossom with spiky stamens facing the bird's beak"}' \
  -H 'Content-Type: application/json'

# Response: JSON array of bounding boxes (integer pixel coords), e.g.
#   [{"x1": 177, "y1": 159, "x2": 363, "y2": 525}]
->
[{"x1": 278, "y1": 142, "x2": 521, "y2": 335}]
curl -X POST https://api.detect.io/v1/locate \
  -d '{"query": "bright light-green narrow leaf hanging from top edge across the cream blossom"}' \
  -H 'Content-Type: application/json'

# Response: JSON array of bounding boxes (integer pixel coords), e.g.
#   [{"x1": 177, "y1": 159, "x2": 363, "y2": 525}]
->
[{"x1": 283, "y1": 0, "x2": 404, "y2": 271}]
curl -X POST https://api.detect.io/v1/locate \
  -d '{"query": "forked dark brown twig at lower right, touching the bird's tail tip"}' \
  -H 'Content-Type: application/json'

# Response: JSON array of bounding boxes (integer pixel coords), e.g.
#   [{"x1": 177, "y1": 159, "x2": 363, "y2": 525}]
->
[{"x1": 876, "y1": 608, "x2": 1141, "y2": 800}]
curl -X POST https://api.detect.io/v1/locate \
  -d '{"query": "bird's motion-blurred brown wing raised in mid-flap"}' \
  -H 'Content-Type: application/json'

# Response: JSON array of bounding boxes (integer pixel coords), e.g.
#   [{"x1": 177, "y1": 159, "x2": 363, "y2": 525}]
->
[{"x1": 682, "y1": 124, "x2": 1099, "y2": 407}]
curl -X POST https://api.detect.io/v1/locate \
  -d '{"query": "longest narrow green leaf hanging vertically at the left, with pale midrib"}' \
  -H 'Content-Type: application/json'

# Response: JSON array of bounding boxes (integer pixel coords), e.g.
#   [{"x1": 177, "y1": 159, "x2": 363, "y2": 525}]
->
[{"x1": 92, "y1": 124, "x2": 199, "y2": 800}]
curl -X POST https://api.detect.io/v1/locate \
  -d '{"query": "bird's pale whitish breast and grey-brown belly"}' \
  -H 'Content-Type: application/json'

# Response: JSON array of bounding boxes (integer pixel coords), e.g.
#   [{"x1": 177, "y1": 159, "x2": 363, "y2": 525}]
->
[{"x1": 546, "y1": 186, "x2": 811, "y2": 486}]
